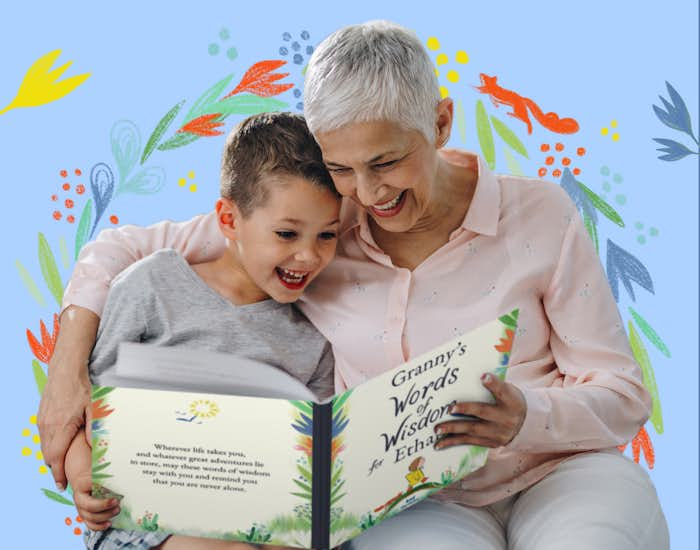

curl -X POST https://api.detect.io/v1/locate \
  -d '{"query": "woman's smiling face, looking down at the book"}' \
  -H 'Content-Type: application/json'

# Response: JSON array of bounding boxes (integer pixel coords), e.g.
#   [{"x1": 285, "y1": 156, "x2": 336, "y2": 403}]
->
[{"x1": 315, "y1": 121, "x2": 438, "y2": 232}]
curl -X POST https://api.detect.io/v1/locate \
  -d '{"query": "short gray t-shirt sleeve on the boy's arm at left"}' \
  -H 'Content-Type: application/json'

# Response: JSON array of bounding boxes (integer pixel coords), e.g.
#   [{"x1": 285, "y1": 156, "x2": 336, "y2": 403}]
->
[{"x1": 90, "y1": 271, "x2": 148, "y2": 382}]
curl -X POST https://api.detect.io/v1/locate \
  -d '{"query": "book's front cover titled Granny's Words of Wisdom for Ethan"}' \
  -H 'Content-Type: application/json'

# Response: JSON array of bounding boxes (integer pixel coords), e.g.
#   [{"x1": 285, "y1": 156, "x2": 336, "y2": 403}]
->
[{"x1": 331, "y1": 310, "x2": 517, "y2": 545}]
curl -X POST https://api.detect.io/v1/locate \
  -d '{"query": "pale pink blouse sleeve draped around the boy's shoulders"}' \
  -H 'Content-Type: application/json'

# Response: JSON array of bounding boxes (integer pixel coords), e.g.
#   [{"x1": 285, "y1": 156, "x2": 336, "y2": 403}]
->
[{"x1": 61, "y1": 212, "x2": 224, "y2": 316}]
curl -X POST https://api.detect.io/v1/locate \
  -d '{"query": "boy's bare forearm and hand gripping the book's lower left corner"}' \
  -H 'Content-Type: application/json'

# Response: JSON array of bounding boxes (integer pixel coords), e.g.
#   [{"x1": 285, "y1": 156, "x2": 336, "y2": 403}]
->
[{"x1": 66, "y1": 429, "x2": 119, "y2": 531}]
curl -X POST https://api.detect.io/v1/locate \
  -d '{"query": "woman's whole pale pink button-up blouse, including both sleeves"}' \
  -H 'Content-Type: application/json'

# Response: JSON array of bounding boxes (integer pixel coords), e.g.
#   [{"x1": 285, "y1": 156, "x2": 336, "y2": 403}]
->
[{"x1": 63, "y1": 150, "x2": 651, "y2": 506}]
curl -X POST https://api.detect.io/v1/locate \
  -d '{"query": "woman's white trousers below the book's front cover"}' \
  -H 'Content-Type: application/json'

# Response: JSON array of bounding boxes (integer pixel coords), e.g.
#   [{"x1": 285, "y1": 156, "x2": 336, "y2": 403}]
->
[{"x1": 343, "y1": 451, "x2": 669, "y2": 550}]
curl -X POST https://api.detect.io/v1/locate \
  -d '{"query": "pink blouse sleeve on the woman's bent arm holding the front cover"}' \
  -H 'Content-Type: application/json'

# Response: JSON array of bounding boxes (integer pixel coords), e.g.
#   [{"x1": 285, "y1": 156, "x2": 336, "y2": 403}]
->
[{"x1": 506, "y1": 205, "x2": 651, "y2": 452}]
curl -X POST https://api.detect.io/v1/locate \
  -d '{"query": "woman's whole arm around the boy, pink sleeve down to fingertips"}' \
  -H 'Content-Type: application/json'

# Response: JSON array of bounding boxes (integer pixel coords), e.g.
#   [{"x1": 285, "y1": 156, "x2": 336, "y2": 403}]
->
[{"x1": 38, "y1": 213, "x2": 224, "y2": 490}]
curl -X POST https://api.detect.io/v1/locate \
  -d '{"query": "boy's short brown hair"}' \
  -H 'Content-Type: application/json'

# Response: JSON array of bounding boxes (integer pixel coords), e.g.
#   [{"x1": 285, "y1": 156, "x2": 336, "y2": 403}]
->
[{"x1": 221, "y1": 113, "x2": 340, "y2": 217}]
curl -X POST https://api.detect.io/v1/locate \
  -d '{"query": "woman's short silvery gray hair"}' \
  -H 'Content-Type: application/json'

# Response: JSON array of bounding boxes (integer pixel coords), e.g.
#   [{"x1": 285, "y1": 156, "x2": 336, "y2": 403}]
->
[{"x1": 304, "y1": 21, "x2": 440, "y2": 144}]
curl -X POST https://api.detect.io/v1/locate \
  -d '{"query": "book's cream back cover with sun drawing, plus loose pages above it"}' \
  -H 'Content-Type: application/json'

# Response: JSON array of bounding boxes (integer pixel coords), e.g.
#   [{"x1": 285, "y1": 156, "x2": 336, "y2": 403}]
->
[{"x1": 93, "y1": 345, "x2": 313, "y2": 548}]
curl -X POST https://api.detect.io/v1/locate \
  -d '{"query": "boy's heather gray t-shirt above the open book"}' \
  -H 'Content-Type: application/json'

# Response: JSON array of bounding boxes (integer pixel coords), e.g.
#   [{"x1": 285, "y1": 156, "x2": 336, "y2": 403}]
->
[{"x1": 90, "y1": 249, "x2": 333, "y2": 398}]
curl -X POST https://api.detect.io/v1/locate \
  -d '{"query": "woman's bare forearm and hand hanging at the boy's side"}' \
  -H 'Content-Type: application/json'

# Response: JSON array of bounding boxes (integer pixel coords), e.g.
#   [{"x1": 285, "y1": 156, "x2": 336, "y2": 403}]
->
[{"x1": 37, "y1": 306, "x2": 100, "y2": 491}]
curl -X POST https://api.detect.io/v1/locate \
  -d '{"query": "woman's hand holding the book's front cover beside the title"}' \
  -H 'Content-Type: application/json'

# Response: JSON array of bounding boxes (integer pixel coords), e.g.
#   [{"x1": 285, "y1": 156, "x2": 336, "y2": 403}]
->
[{"x1": 435, "y1": 374, "x2": 527, "y2": 449}]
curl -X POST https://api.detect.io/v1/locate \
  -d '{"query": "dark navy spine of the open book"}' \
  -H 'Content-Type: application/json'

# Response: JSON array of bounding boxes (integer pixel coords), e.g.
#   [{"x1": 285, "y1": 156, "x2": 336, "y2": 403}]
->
[{"x1": 311, "y1": 403, "x2": 333, "y2": 550}]
